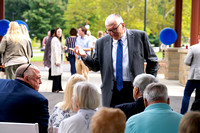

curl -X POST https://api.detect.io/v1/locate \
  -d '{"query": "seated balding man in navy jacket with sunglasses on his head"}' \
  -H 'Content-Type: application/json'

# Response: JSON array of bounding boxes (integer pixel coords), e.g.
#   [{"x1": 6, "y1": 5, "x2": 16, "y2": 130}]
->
[{"x1": 0, "y1": 64, "x2": 49, "y2": 133}]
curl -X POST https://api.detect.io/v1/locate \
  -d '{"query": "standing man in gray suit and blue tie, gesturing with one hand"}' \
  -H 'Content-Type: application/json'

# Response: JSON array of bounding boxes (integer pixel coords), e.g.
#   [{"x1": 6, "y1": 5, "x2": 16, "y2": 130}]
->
[{"x1": 71, "y1": 14, "x2": 158, "y2": 107}]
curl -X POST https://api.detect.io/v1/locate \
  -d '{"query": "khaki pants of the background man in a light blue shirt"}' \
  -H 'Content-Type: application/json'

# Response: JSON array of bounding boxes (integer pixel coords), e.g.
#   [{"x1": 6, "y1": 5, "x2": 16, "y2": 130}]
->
[{"x1": 76, "y1": 59, "x2": 89, "y2": 80}]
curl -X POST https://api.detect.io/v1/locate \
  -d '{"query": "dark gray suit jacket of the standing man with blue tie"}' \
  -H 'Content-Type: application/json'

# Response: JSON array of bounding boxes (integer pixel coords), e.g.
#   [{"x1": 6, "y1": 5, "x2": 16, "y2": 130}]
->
[{"x1": 83, "y1": 30, "x2": 158, "y2": 107}]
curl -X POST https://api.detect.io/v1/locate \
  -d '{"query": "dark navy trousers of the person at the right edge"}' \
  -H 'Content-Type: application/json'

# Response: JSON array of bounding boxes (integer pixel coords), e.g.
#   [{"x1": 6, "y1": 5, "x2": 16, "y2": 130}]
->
[{"x1": 181, "y1": 80, "x2": 200, "y2": 114}]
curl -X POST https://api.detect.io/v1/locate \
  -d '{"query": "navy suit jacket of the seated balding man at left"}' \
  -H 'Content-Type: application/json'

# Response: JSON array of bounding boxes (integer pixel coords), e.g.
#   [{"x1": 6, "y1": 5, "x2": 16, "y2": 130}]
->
[{"x1": 0, "y1": 79, "x2": 49, "y2": 133}]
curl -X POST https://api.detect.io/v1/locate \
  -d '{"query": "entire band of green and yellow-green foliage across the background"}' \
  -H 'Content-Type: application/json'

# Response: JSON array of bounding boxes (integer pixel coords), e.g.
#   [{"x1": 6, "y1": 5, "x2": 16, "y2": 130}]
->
[{"x1": 5, "y1": 0, "x2": 191, "y2": 46}]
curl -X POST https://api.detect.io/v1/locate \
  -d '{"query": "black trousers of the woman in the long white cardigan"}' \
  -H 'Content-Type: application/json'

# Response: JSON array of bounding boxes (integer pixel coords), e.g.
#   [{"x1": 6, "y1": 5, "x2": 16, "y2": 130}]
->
[{"x1": 52, "y1": 75, "x2": 62, "y2": 92}]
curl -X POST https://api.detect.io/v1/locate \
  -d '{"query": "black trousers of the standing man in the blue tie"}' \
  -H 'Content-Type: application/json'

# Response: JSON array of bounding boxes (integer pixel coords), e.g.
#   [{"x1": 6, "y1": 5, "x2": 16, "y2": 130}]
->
[{"x1": 110, "y1": 81, "x2": 134, "y2": 107}]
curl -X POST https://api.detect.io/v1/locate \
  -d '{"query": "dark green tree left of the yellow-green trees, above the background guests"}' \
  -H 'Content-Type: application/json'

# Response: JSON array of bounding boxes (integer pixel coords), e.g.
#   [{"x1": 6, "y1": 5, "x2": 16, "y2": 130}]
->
[{"x1": 23, "y1": 0, "x2": 65, "y2": 40}]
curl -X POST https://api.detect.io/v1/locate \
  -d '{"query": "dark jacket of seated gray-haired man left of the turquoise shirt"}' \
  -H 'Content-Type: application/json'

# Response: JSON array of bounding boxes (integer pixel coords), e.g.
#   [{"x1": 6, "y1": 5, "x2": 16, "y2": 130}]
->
[{"x1": 115, "y1": 97, "x2": 145, "y2": 120}]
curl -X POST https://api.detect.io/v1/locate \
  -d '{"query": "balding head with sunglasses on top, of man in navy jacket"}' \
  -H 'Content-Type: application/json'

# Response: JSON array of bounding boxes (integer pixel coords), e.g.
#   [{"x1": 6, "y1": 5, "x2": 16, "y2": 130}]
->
[{"x1": 15, "y1": 64, "x2": 42, "y2": 91}]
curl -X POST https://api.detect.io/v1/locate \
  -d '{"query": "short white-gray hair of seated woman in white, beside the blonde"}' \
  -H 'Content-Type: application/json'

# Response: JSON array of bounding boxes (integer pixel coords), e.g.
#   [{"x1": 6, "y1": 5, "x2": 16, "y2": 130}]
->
[{"x1": 73, "y1": 81, "x2": 100, "y2": 109}]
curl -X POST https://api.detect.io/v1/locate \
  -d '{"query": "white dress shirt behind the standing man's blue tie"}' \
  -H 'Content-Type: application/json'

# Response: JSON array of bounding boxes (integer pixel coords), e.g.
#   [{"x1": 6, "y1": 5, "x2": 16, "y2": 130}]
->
[{"x1": 112, "y1": 32, "x2": 131, "y2": 81}]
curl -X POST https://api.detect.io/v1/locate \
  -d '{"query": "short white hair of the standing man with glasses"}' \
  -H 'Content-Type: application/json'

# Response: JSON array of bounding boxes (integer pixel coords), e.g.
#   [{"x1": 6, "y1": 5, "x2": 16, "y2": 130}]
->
[{"x1": 105, "y1": 14, "x2": 124, "y2": 26}]
